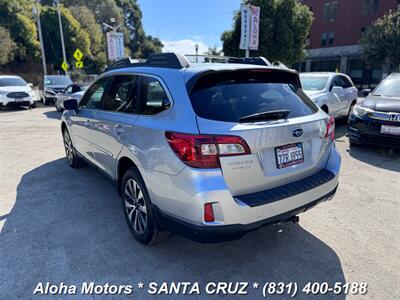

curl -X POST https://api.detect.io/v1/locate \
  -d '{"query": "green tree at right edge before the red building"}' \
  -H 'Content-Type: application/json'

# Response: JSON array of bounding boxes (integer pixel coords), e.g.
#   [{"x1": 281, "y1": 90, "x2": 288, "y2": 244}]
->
[{"x1": 361, "y1": 11, "x2": 400, "y2": 65}]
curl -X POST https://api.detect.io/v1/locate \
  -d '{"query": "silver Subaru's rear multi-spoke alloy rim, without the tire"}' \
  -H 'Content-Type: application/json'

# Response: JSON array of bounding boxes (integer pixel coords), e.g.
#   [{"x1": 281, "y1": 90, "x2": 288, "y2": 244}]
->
[{"x1": 124, "y1": 178, "x2": 147, "y2": 234}]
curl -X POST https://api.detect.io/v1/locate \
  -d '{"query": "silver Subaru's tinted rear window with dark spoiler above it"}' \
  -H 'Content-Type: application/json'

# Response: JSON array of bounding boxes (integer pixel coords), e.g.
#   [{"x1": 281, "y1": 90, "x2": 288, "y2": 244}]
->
[{"x1": 190, "y1": 69, "x2": 318, "y2": 122}]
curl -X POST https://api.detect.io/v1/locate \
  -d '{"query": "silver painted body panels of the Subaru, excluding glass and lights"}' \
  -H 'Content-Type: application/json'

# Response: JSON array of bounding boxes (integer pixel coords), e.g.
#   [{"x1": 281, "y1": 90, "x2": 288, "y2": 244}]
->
[{"x1": 62, "y1": 64, "x2": 340, "y2": 226}]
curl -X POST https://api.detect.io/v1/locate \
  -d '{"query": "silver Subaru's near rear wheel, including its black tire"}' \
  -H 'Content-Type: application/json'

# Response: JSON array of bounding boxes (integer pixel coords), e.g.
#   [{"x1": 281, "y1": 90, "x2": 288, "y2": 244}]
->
[{"x1": 121, "y1": 168, "x2": 169, "y2": 244}]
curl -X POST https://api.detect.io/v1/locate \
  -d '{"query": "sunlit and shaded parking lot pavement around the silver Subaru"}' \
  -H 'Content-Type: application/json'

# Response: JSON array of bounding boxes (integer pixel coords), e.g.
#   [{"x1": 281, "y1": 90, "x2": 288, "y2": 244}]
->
[{"x1": 0, "y1": 107, "x2": 400, "y2": 299}]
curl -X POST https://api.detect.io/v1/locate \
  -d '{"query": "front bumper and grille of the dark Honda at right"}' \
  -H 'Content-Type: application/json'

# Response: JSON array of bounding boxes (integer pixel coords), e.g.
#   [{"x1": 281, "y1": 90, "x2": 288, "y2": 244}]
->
[{"x1": 347, "y1": 113, "x2": 400, "y2": 148}]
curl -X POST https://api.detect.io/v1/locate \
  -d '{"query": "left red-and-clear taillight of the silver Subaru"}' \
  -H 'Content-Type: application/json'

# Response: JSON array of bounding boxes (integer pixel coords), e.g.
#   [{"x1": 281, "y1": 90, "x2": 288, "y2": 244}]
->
[{"x1": 165, "y1": 131, "x2": 251, "y2": 169}]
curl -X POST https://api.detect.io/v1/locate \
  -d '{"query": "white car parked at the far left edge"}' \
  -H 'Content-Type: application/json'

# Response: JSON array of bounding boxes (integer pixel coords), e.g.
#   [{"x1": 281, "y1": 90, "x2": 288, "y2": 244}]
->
[{"x1": 0, "y1": 75, "x2": 36, "y2": 109}]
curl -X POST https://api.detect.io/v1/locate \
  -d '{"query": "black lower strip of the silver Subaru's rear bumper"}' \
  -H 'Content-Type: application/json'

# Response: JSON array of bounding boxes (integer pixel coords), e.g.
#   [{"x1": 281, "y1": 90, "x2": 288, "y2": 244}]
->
[{"x1": 156, "y1": 185, "x2": 337, "y2": 243}]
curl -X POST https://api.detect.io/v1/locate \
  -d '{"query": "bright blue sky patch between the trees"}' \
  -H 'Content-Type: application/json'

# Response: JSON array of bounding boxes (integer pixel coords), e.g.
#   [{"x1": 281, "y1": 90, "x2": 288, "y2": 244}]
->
[{"x1": 138, "y1": 0, "x2": 241, "y2": 54}]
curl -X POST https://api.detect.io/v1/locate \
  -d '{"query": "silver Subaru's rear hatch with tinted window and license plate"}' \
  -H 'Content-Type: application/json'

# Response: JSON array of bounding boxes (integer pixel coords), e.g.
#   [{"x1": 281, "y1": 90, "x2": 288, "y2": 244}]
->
[{"x1": 187, "y1": 68, "x2": 334, "y2": 196}]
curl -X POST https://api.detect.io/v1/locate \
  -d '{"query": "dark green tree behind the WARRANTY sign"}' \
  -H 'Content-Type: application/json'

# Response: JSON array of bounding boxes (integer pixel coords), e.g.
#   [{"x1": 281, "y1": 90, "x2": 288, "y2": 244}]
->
[{"x1": 221, "y1": 0, "x2": 313, "y2": 65}]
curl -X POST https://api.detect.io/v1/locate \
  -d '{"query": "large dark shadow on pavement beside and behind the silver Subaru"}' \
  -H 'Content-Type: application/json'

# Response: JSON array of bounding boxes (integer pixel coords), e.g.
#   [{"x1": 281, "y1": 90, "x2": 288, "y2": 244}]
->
[{"x1": 0, "y1": 159, "x2": 345, "y2": 299}]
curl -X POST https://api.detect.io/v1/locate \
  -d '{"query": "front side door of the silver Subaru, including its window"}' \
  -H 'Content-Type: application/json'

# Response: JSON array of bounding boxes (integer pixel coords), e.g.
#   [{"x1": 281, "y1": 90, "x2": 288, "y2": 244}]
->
[{"x1": 71, "y1": 78, "x2": 110, "y2": 163}]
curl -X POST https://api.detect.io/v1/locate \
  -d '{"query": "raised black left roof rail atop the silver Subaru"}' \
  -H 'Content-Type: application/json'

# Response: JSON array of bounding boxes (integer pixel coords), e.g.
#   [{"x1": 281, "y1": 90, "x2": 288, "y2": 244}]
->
[{"x1": 105, "y1": 52, "x2": 189, "y2": 72}]
